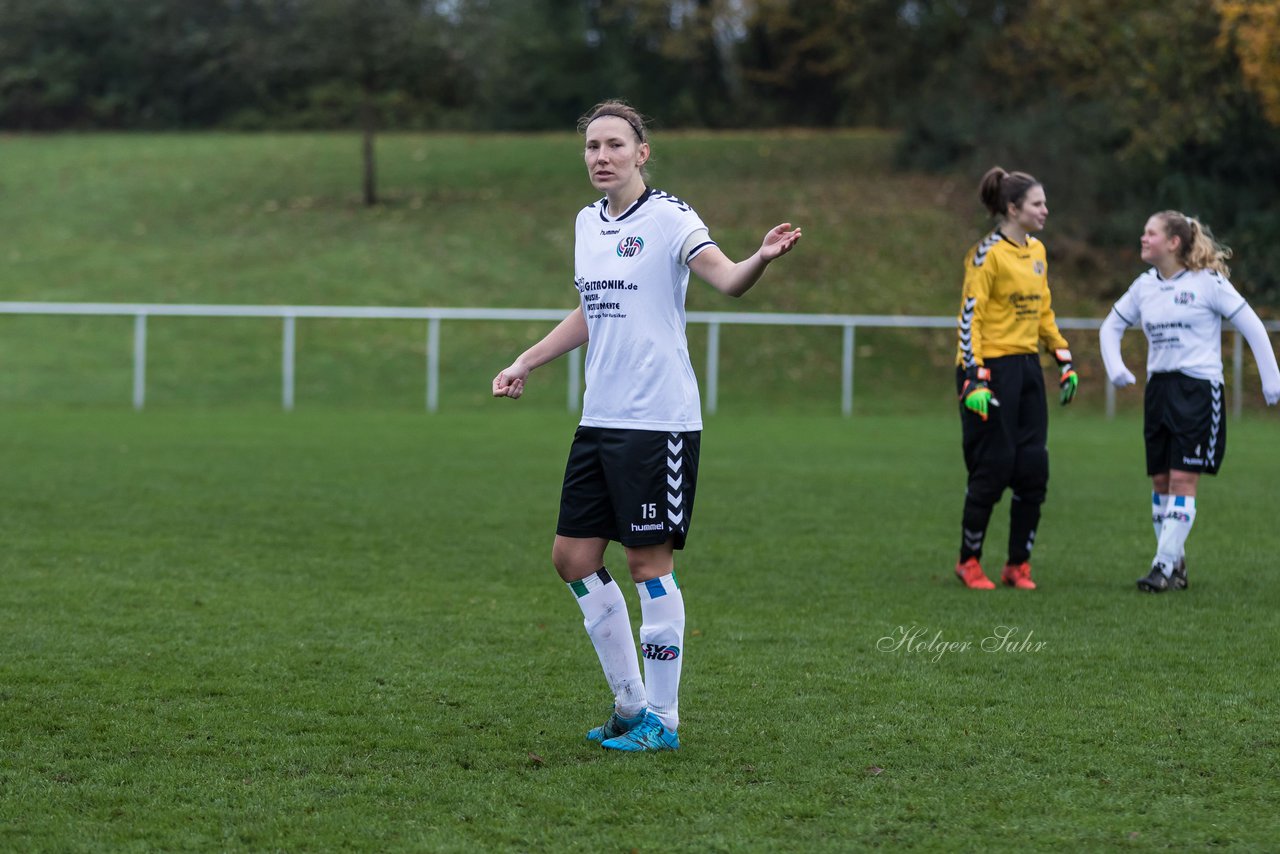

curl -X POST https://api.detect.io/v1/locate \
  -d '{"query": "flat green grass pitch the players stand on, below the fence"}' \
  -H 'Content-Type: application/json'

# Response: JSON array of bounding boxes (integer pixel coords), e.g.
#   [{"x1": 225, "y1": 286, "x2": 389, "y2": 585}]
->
[{"x1": 0, "y1": 402, "x2": 1280, "y2": 851}]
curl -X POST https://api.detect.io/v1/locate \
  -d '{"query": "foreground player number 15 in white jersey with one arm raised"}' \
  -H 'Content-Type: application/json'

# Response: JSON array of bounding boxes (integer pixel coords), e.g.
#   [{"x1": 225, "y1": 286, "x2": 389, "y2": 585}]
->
[{"x1": 493, "y1": 101, "x2": 800, "y2": 750}]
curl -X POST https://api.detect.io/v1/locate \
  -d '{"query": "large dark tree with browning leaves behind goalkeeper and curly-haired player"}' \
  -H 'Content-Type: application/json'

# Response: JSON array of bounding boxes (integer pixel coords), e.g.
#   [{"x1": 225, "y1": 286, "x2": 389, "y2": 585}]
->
[{"x1": 902, "y1": 0, "x2": 1280, "y2": 298}]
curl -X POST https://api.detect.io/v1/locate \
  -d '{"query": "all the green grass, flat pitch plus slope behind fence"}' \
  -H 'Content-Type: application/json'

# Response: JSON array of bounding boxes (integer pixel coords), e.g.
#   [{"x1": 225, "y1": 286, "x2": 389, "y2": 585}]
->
[{"x1": 0, "y1": 126, "x2": 1280, "y2": 851}]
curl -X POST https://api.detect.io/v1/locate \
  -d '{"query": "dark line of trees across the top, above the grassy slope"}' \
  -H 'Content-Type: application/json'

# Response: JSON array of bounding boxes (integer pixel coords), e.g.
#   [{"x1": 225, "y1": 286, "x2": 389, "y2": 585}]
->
[{"x1": 0, "y1": 0, "x2": 1280, "y2": 300}]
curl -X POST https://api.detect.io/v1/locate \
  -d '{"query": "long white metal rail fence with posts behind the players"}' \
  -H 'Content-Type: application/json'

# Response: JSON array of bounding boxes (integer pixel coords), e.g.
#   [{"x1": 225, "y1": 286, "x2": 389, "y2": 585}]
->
[{"x1": 0, "y1": 302, "x2": 1280, "y2": 417}]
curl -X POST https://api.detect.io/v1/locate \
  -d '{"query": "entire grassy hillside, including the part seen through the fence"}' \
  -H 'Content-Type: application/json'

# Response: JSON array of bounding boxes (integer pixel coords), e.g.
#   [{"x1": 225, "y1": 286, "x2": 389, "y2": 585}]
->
[{"x1": 0, "y1": 132, "x2": 1259, "y2": 411}]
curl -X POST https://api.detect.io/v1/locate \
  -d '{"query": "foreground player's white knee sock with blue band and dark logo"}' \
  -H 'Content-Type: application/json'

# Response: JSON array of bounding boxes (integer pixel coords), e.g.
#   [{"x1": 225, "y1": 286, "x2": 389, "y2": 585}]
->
[{"x1": 636, "y1": 572, "x2": 685, "y2": 730}]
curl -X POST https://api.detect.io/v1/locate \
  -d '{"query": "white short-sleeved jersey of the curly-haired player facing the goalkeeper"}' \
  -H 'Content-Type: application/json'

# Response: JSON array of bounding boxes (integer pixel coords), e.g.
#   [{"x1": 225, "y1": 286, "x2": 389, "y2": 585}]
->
[{"x1": 1112, "y1": 268, "x2": 1247, "y2": 383}]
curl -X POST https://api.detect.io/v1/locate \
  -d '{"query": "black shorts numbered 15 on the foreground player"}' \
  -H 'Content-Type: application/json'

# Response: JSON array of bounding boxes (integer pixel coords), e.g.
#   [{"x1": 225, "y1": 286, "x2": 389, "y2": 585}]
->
[{"x1": 556, "y1": 426, "x2": 701, "y2": 549}]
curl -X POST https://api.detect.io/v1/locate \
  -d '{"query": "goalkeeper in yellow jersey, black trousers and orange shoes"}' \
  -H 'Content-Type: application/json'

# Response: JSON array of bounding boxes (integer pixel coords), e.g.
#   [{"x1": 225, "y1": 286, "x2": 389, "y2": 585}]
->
[{"x1": 956, "y1": 166, "x2": 1079, "y2": 590}]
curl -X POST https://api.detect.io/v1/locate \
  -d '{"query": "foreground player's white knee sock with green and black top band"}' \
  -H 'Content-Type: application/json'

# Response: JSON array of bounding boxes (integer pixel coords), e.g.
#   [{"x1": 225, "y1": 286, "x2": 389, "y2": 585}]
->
[{"x1": 568, "y1": 566, "x2": 646, "y2": 717}]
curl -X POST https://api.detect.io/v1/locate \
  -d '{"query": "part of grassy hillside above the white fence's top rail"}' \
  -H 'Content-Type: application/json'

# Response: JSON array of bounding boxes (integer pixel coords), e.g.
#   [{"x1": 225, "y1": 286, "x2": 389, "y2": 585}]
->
[{"x1": 0, "y1": 133, "x2": 980, "y2": 312}]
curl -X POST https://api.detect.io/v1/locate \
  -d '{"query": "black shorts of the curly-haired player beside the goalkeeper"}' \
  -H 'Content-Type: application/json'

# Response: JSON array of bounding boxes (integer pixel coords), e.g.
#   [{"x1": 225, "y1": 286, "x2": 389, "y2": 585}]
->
[{"x1": 1142, "y1": 371, "x2": 1226, "y2": 475}]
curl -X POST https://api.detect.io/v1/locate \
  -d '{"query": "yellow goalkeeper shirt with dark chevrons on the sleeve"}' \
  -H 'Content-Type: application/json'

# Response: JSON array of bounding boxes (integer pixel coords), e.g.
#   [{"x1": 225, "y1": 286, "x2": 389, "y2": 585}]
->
[{"x1": 956, "y1": 230, "x2": 1068, "y2": 367}]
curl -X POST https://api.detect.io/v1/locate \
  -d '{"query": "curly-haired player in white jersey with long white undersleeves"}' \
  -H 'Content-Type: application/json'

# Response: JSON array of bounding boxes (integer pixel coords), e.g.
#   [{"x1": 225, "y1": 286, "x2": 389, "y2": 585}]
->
[{"x1": 1098, "y1": 210, "x2": 1280, "y2": 593}]
